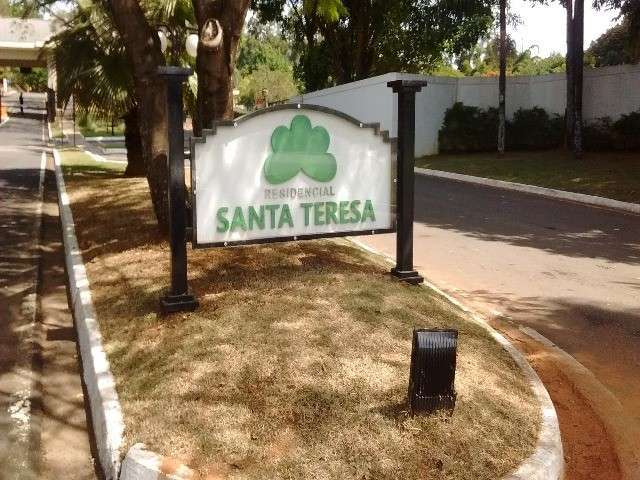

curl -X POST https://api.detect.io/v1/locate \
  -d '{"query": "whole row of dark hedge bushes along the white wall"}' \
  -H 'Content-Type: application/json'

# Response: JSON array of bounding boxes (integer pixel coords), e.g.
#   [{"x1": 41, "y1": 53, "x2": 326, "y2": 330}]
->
[{"x1": 438, "y1": 102, "x2": 640, "y2": 153}]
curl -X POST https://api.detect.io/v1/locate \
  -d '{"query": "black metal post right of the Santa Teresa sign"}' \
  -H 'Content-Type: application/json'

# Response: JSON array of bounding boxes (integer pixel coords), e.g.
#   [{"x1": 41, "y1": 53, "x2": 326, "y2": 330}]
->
[{"x1": 387, "y1": 80, "x2": 427, "y2": 285}]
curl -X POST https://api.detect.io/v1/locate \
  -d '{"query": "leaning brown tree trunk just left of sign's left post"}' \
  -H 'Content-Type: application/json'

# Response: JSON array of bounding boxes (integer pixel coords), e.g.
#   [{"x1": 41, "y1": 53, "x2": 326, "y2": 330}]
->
[{"x1": 108, "y1": 0, "x2": 169, "y2": 233}]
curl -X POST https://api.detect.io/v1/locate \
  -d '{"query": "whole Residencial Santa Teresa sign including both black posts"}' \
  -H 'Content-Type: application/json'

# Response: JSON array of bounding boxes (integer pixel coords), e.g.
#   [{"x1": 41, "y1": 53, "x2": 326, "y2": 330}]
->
[{"x1": 158, "y1": 66, "x2": 426, "y2": 313}]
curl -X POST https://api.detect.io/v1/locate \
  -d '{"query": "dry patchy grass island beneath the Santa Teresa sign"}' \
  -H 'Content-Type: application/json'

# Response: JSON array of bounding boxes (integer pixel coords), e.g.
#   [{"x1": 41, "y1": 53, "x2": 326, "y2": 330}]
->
[{"x1": 63, "y1": 152, "x2": 540, "y2": 480}]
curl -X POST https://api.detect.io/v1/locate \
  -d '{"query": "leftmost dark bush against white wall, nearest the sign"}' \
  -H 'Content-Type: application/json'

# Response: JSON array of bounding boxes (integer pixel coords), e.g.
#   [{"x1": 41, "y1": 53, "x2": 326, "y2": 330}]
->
[{"x1": 438, "y1": 102, "x2": 498, "y2": 153}]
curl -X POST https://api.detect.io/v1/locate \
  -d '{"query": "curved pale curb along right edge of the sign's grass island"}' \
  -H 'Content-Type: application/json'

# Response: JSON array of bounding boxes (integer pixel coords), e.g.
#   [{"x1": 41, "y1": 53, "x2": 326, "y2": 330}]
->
[{"x1": 348, "y1": 238, "x2": 564, "y2": 480}]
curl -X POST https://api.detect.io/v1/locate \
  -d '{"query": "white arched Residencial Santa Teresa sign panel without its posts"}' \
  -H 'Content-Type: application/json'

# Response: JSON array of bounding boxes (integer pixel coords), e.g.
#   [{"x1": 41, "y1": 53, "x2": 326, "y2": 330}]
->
[{"x1": 191, "y1": 104, "x2": 397, "y2": 248}]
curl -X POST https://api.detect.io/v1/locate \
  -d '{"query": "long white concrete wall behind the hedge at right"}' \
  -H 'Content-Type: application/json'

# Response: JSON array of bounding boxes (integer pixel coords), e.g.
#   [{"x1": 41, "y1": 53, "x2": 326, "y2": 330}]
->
[{"x1": 291, "y1": 65, "x2": 640, "y2": 156}]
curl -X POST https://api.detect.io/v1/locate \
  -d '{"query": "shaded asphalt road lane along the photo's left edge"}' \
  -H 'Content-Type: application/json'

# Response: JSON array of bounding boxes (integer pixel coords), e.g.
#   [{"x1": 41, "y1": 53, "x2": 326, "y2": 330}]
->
[{"x1": 0, "y1": 111, "x2": 44, "y2": 480}]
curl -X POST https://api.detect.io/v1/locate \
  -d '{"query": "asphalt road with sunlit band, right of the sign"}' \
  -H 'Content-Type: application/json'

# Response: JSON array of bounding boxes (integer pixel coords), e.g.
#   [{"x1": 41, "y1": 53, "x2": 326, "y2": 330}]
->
[{"x1": 361, "y1": 172, "x2": 640, "y2": 422}]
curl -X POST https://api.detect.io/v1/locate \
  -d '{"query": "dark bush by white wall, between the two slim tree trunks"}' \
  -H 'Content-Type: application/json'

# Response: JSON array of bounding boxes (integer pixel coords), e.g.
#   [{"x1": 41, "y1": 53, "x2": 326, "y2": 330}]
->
[{"x1": 507, "y1": 107, "x2": 564, "y2": 150}]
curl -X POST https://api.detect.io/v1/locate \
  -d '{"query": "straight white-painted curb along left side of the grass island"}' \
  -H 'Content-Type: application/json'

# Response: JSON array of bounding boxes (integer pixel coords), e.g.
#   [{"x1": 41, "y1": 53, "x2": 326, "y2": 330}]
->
[{"x1": 53, "y1": 149, "x2": 124, "y2": 480}]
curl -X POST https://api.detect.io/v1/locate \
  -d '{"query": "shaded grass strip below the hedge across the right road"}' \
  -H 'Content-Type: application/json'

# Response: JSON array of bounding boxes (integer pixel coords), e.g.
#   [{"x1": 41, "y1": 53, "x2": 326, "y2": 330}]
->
[{"x1": 416, "y1": 150, "x2": 640, "y2": 203}]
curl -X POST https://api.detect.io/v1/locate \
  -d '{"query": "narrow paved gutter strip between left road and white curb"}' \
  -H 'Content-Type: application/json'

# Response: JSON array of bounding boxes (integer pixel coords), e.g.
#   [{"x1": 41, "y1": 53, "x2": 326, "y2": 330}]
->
[{"x1": 38, "y1": 157, "x2": 96, "y2": 480}]
